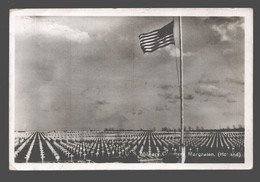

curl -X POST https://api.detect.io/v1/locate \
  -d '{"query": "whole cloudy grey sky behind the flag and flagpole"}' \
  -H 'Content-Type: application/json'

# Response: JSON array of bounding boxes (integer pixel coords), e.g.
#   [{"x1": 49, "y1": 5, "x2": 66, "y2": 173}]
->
[{"x1": 15, "y1": 16, "x2": 244, "y2": 130}]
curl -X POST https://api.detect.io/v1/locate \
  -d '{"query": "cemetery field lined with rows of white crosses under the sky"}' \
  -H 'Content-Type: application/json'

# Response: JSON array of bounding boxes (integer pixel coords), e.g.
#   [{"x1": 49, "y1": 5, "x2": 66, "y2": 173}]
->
[{"x1": 14, "y1": 130, "x2": 244, "y2": 163}]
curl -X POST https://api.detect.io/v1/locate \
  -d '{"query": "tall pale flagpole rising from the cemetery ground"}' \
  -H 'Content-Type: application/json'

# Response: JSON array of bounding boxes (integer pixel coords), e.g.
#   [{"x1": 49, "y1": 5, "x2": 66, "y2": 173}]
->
[{"x1": 179, "y1": 16, "x2": 185, "y2": 163}]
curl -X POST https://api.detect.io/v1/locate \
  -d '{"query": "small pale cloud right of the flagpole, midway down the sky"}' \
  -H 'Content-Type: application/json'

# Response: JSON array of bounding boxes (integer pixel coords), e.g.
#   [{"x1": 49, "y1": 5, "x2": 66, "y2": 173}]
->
[{"x1": 195, "y1": 85, "x2": 229, "y2": 97}]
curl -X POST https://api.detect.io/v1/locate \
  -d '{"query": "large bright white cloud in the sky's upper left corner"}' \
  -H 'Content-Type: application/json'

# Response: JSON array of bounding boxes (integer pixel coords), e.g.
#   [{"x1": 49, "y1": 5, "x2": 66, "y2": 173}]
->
[{"x1": 16, "y1": 17, "x2": 90, "y2": 43}]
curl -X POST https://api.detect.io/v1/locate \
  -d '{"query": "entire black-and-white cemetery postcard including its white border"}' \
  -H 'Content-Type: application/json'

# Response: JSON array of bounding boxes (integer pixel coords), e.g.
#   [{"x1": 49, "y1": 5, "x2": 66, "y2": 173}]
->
[{"x1": 9, "y1": 8, "x2": 253, "y2": 170}]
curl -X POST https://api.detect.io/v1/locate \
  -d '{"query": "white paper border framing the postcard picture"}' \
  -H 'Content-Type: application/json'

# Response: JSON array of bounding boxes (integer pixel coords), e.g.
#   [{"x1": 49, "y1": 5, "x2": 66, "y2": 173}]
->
[{"x1": 9, "y1": 8, "x2": 253, "y2": 170}]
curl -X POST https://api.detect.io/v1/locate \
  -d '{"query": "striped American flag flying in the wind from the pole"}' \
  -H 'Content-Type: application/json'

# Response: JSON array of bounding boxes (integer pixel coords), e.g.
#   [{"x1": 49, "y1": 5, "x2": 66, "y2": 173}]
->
[{"x1": 139, "y1": 21, "x2": 175, "y2": 53}]
